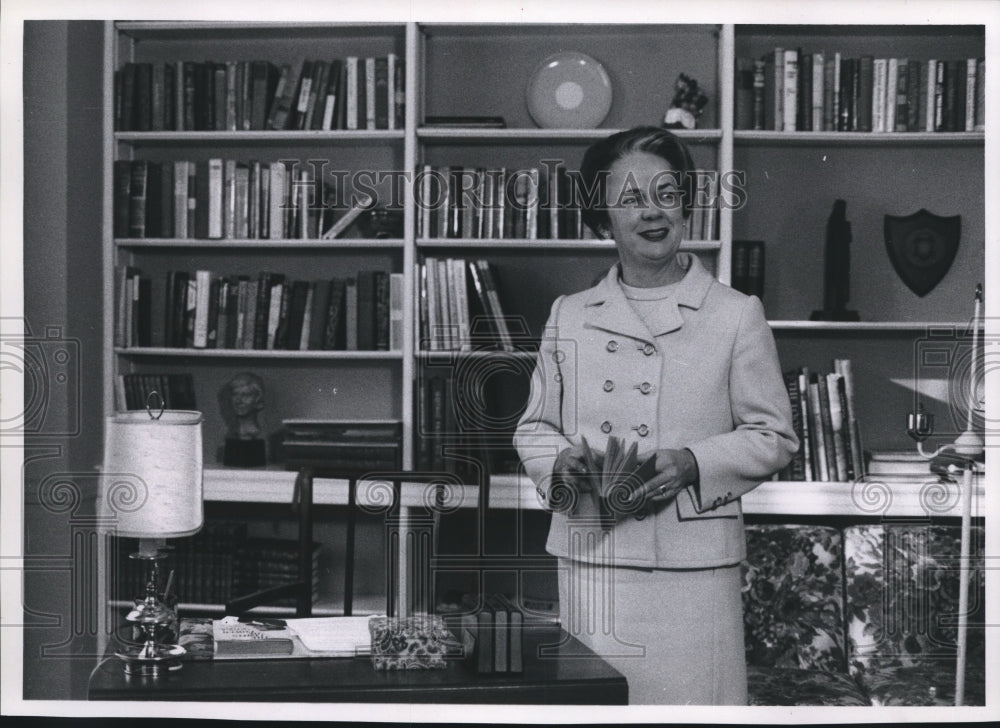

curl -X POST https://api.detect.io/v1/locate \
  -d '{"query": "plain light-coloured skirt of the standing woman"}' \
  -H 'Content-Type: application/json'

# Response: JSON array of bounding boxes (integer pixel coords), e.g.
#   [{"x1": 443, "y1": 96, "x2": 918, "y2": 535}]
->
[{"x1": 559, "y1": 559, "x2": 747, "y2": 705}]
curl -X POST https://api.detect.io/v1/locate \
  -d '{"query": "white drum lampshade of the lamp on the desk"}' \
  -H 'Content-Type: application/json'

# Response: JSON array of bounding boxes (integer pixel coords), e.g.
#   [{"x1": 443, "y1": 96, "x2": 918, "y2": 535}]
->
[{"x1": 99, "y1": 410, "x2": 203, "y2": 539}]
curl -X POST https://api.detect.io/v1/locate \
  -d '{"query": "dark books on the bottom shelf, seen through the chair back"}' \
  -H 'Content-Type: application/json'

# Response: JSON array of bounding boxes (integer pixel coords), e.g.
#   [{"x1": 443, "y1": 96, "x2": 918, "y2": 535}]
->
[{"x1": 233, "y1": 538, "x2": 321, "y2": 607}]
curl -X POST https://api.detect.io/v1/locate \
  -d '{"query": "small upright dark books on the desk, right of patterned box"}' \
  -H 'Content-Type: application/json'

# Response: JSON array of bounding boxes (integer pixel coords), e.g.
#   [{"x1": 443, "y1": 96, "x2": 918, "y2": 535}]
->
[{"x1": 462, "y1": 594, "x2": 524, "y2": 673}]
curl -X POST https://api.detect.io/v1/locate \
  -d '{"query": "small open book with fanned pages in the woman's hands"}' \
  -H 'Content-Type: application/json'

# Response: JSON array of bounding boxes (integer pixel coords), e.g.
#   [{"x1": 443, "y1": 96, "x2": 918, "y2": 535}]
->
[{"x1": 583, "y1": 435, "x2": 656, "y2": 523}]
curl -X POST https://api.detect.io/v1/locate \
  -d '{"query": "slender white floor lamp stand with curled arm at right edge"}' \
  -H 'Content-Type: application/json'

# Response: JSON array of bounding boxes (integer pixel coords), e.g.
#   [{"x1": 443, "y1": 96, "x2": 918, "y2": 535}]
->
[{"x1": 906, "y1": 285, "x2": 985, "y2": 706}]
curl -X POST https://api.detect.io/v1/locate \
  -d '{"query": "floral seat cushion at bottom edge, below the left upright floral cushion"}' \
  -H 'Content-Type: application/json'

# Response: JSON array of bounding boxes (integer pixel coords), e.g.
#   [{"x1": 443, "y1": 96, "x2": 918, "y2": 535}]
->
[{"x1": 747, "y1": 665, "x2": 870, "y2": 706}]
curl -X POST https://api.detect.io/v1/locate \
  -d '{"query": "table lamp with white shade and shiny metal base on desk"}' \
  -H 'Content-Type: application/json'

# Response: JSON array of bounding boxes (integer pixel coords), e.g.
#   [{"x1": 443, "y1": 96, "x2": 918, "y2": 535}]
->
[{"x1": 99, "y1": 400, "x2": 203, "y2": 676}]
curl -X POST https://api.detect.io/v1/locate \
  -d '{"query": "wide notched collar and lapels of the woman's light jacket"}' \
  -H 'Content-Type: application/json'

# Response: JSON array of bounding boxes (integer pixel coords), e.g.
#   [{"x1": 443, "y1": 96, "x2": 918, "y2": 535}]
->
[{"x1": 584, "y1": 253, "x2": 714, "y2": 341}]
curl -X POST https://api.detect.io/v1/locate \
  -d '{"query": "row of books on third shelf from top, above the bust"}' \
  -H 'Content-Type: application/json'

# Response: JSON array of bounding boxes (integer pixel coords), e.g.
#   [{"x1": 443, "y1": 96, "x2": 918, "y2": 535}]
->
[{"x1": 115, "y1": 268, "x2": 403, "y2": 351}]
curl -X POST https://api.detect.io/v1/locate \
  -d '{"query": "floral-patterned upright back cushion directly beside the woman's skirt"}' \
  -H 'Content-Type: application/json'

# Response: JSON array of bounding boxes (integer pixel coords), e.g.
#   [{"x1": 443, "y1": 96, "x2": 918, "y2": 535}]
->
[{"x1": 743, "y1": 525, "x2": 846, "y2": 672}]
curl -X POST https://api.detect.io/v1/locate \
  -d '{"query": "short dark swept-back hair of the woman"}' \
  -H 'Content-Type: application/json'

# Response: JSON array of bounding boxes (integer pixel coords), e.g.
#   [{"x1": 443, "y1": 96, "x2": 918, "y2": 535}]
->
[{"x1": 580, "y1": 126, "x2": 694, "y2": 235}]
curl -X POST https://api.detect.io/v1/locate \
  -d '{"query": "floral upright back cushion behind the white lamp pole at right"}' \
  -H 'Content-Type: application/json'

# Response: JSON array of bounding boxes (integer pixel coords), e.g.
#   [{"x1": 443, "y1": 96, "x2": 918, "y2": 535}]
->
[{"x1": 844, "y1": 524, "x2": 985, "y2": 688}]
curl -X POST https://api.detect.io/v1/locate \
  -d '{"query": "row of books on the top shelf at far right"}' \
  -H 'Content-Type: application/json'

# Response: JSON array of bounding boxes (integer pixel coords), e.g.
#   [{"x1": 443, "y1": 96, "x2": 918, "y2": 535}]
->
[{"x1": 735, "y1": 48, "x2": 986, "y2": 132}]
